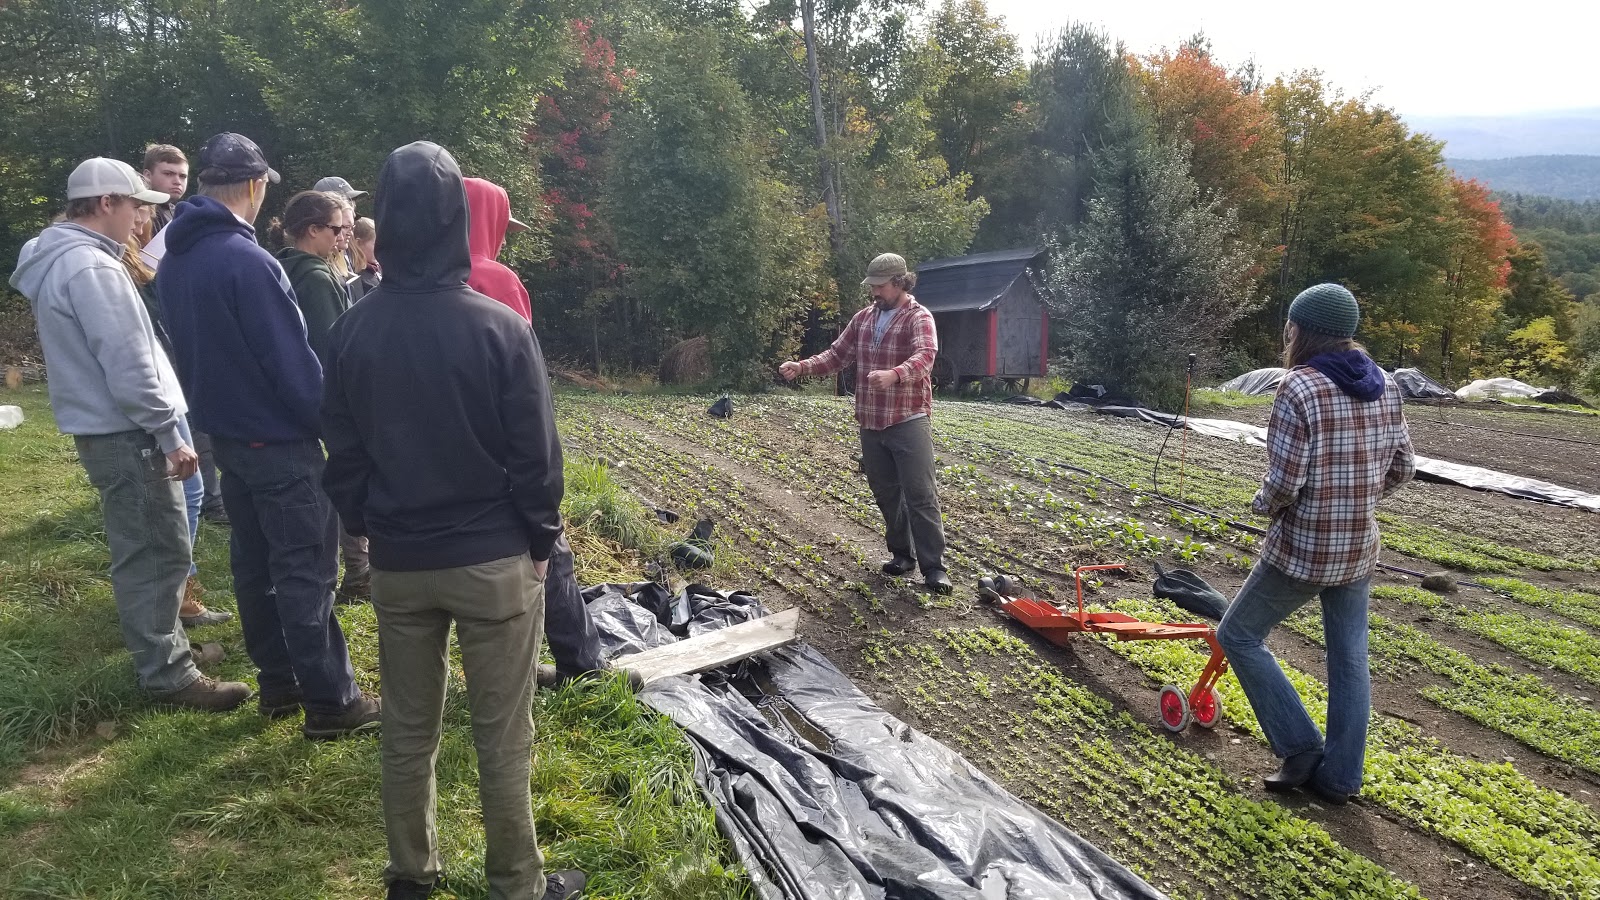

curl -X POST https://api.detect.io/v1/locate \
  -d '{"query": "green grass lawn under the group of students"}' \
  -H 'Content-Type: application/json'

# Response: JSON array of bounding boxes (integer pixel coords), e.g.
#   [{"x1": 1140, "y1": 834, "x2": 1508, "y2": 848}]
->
[{"x1": 0, "y1": 388, "x2": 747, "y2": 900}]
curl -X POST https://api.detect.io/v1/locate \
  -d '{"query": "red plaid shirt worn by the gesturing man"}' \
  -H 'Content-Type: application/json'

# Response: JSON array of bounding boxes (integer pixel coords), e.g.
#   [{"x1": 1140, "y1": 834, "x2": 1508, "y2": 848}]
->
[{"x1": 800, "y1": 295, "x2": 939, "y2": 431}]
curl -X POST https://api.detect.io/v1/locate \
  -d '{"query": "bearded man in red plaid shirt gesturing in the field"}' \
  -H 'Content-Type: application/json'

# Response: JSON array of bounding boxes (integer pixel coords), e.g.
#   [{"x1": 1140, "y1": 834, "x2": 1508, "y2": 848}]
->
[{"x1": 778, "y1": 253, "x2": 950, "y2": 594}]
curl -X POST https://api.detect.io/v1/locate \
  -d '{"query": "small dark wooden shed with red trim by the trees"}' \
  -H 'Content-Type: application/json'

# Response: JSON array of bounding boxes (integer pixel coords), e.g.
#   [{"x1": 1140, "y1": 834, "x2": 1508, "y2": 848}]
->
[{"x1": 912, "y1": 248, "x2": 1050, "y2": 388}]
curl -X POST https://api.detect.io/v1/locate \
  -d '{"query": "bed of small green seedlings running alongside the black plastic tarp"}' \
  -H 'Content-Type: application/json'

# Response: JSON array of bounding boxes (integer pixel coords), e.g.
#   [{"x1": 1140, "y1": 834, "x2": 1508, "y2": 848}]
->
[{"x1": 880, "y1": 628, "x2": 1421, "y2": 900}]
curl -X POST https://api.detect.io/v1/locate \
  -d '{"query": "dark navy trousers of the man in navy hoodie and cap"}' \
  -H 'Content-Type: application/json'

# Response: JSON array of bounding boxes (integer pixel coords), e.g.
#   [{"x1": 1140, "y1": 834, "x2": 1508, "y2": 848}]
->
[{"x1": 211, "y1": 436, "x2": 362, "y2": 714}]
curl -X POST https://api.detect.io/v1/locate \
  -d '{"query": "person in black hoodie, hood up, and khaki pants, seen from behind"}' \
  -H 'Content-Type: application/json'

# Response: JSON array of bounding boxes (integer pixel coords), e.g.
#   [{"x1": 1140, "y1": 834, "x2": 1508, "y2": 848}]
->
[{"x1": 322, "y1": 141, "x2": 586, "y2": 900}]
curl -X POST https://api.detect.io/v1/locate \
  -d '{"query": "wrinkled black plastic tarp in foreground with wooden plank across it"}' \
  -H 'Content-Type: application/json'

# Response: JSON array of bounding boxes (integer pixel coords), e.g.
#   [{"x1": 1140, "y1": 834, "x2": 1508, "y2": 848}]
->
[{"x1": 584, "y1": 585, "x2": 1163, "y2": 900}]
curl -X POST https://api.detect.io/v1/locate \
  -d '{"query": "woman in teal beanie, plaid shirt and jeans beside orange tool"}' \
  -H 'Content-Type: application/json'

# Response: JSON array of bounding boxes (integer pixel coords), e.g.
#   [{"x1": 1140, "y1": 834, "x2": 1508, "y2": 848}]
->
[{"x1": 1218, "y1": 283, "x2": 1416, "y2": 806}]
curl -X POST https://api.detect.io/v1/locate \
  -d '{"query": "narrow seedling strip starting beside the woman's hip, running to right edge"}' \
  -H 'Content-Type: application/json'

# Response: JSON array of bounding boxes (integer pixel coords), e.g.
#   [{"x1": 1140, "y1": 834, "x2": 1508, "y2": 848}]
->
[{"x1": 1373, "y1": 586, "x2": 1600, "y2": 682}]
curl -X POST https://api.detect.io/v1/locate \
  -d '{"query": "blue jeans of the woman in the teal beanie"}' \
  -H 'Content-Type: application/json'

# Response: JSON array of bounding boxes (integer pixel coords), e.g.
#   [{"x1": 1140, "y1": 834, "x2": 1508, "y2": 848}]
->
[{"x1": 1216, "y1": 562, "x2": 1373, "y2": 794}]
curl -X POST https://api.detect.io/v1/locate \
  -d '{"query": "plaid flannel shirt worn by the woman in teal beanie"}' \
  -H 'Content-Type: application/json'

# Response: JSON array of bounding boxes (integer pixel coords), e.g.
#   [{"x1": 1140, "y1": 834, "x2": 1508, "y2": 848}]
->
[{"x1": 1253, "y1": 365, "x2": 1416, "y2": 585}]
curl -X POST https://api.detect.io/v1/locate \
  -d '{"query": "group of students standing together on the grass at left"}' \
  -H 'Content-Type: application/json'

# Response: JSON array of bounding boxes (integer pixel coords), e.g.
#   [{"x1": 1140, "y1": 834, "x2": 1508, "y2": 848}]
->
[{"x1": 11, "y1": 133, "x2": 595, "y2": 900}]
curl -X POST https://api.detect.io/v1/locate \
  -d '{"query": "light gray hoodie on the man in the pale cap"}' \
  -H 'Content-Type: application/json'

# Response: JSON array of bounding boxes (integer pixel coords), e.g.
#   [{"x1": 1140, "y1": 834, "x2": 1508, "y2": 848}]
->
[{"x1": 11, "y1": 223, "x2": 189, "y2": 453}]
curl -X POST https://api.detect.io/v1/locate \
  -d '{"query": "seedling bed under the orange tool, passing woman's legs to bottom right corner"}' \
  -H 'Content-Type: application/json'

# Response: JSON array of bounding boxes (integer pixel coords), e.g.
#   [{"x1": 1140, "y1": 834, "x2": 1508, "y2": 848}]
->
[{"x1": 1109, "y1": 599, "x2": 1600, "y2": 897}]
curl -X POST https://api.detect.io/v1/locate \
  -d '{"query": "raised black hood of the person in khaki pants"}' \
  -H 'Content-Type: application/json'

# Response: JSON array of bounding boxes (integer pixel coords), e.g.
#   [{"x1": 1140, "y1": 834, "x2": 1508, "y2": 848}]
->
[{"x1": 378, "y1": 141, "x2": 472, "y2": 293}]
